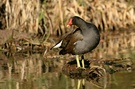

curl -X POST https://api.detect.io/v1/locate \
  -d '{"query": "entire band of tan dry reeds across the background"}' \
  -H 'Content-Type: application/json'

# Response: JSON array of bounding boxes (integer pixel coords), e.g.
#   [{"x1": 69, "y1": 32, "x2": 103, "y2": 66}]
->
[{"x1": 1, "y1": 0, "x2": 135, "y2": 34}]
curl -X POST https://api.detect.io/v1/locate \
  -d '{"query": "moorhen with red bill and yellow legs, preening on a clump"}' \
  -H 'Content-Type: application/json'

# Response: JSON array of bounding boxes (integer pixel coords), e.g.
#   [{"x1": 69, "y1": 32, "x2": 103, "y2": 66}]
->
[{"x1": 52, "y1": 16, "x2": 100, "y2": 68}]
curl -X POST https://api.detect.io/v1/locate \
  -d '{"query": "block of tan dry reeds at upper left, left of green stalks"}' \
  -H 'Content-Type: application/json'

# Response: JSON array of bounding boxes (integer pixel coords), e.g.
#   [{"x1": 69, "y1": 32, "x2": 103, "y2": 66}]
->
[{"x1": 5, "y1": 0, "x2": 40, "y2": 33}]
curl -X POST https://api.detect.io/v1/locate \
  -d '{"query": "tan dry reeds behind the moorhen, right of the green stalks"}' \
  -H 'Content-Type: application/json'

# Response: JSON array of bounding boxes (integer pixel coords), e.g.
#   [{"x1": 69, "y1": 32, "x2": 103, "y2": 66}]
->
[{"x1": 47, "y1": 0, "x2": 135, "y2": 34}]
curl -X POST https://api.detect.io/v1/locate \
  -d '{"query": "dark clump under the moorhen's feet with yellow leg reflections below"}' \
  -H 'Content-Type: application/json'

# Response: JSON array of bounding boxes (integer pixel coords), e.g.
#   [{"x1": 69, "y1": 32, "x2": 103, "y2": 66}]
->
[{"x1": 63, "y1": 60, "x2": 107, "y2": 89}]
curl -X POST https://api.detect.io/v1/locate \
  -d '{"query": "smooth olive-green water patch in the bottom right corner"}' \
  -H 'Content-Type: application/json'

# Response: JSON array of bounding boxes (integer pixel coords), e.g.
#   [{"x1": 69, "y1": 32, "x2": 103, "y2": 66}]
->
[{"x1": 107, "y1": 71, "x2": 135, "y2": 89}]
